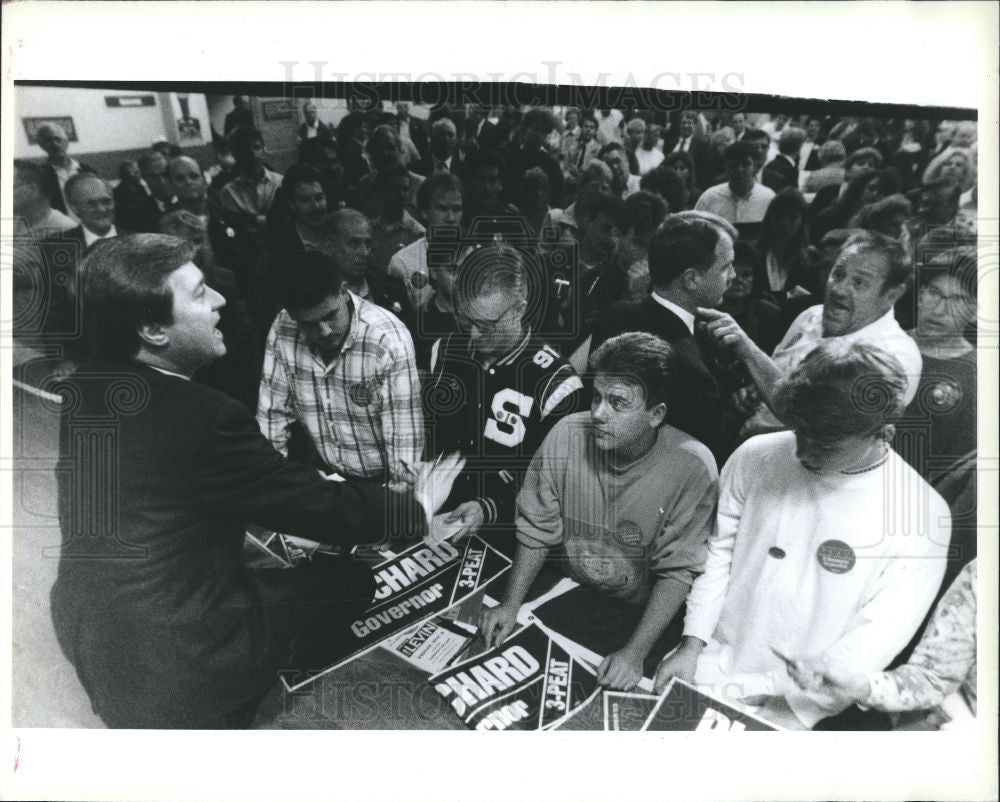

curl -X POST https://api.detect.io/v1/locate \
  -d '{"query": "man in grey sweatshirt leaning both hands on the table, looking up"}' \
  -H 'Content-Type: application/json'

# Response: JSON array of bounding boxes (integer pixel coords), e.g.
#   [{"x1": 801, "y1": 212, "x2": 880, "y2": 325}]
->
[{"x1": 481, "y1": 333, "x2": 718, "y2": 690}]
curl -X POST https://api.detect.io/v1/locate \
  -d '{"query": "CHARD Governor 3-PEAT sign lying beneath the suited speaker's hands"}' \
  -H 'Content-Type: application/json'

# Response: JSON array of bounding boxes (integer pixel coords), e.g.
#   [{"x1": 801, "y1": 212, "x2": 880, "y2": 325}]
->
[{"x1": 281, "y1": 536, "x2": 511, "y2": 691}]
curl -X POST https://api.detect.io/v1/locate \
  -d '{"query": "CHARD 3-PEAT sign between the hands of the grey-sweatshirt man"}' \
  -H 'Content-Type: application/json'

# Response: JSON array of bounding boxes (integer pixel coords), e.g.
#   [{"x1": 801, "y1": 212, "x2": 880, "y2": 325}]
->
[{"x1": 430, "y1": 624, "x2": 598, "y2": 731}]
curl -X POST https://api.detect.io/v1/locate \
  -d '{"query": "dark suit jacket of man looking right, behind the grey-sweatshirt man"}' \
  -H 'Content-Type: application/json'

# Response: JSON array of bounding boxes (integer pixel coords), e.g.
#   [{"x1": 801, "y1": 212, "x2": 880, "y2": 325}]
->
[{"x1": 591, "y1": 298, "x2": 725, "y2": 465}]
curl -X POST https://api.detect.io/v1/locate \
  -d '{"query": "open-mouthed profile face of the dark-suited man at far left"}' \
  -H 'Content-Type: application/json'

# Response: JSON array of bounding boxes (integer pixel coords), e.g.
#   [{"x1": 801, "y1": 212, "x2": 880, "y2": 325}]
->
[{"x1": 163, "y1": 262, "x2": 226, "y2": 376}]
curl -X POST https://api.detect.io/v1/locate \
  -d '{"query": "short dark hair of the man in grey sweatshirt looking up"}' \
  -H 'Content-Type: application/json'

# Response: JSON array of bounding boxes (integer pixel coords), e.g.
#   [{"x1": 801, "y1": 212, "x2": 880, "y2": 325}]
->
[{"x1": 590, "y1": 331, "x2": 674, "y2": 412}]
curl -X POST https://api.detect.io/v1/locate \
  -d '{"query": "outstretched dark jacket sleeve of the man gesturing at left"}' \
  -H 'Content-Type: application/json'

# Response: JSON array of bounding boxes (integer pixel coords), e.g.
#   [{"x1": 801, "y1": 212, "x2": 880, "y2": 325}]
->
[{"x1": 191, "y1": 397, "x2": 424, "y2": 546}]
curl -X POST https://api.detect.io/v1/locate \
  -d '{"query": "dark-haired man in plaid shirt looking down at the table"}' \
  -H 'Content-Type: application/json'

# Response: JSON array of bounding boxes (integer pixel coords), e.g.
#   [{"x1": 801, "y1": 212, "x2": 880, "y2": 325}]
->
[{"x1": 257, "y1": 250, "x2": 424, "y2": 481}]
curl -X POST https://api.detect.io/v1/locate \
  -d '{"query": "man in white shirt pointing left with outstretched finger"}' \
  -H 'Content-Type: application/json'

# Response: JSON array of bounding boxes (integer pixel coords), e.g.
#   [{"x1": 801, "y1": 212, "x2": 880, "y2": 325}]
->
[{"x1": 698, "y1": 231, "x2": 922, "y2": 438}]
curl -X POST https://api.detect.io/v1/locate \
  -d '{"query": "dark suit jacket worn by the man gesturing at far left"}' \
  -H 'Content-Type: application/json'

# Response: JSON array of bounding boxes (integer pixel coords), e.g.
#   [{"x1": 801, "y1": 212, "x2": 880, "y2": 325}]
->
[{"x1": 52, "y1": 362, "x2": 423, "y2": 728}]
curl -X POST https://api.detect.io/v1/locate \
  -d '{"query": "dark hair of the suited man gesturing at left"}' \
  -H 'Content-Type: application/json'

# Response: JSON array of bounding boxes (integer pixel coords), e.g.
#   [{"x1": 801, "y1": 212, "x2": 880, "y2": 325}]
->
[{"x1": 79, "y1": 234, "x2": 194, "y2": 362}]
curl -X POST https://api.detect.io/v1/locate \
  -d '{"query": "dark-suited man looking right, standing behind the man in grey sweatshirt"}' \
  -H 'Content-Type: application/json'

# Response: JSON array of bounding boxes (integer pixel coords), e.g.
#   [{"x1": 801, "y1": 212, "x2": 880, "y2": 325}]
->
[{"x1": 591, "y1": 212, "x2": 736, "y2": 465}]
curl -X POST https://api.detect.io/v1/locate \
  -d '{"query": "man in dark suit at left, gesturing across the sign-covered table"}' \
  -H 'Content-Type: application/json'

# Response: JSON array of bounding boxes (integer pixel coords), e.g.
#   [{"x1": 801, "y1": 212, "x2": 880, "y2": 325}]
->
[{"x1": 52, "y1": 234, "x2": 461, "y2": 728}]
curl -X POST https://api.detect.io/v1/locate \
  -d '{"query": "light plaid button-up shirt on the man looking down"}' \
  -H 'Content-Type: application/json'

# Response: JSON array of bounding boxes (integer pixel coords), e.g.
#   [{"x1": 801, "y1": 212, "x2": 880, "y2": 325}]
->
[{"x1": 257, "y1": 293, "x2": 424, "y2": 481}]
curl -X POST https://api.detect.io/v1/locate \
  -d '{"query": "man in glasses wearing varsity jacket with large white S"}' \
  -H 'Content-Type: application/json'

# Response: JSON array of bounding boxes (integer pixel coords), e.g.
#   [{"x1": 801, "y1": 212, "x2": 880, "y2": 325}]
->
[{"x1": 425, "y1": 241, "x2": 583, "y2": 551}]
